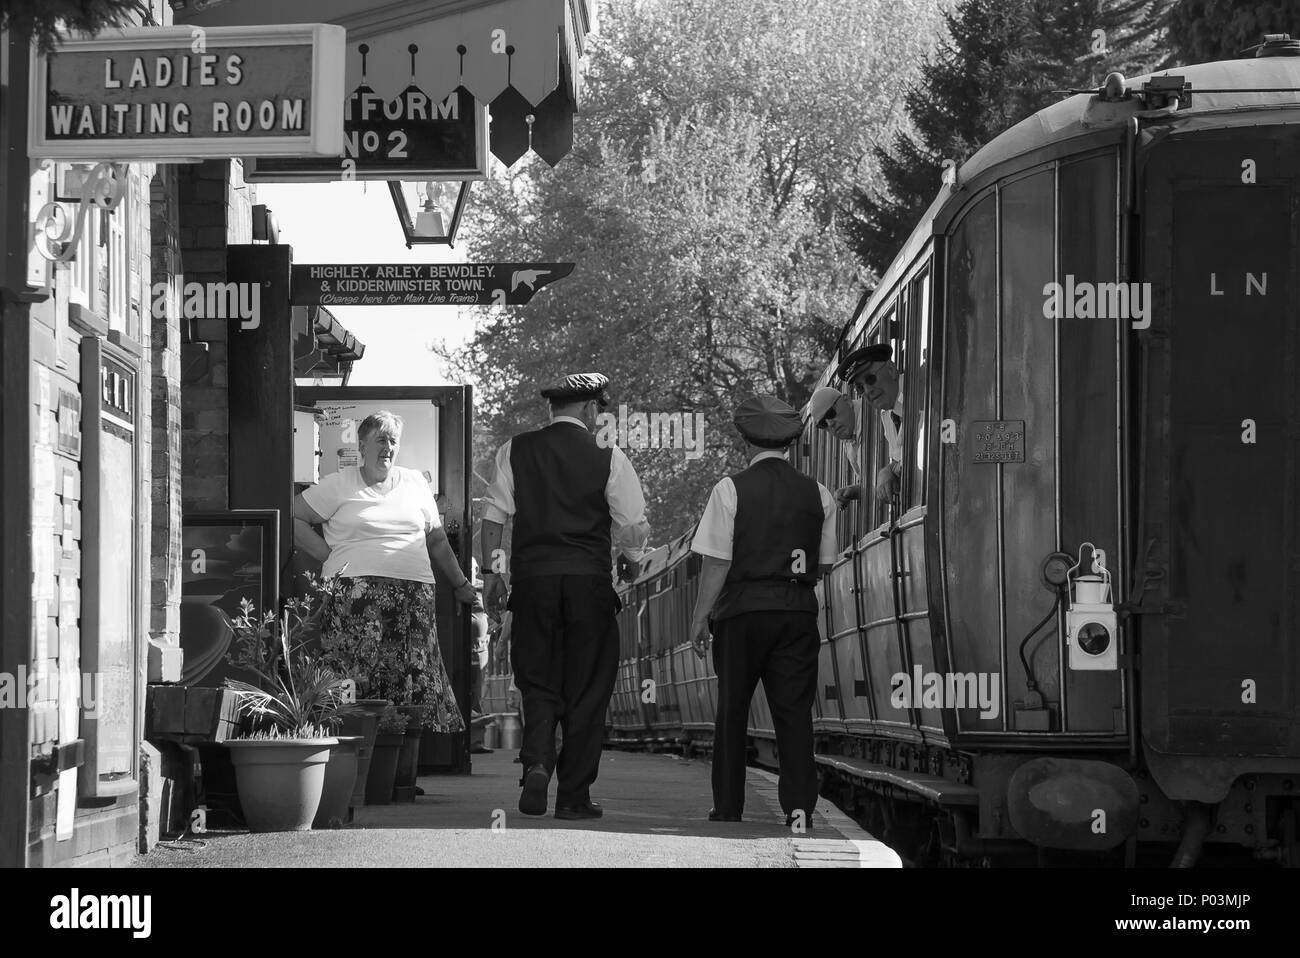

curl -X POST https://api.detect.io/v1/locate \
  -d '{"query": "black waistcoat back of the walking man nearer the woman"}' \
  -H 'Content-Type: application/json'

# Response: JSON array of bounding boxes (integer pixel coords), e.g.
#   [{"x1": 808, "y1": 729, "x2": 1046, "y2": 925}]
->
[{"x1": 510, "y1": 422, "x2": 614, "y2": 580}]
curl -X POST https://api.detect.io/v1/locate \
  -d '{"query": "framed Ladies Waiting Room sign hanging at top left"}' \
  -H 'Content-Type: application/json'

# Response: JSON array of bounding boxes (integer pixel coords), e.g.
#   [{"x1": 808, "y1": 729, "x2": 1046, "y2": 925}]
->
[{"x1": 27, "y1": 23, "x2": 346, "y2": 161}]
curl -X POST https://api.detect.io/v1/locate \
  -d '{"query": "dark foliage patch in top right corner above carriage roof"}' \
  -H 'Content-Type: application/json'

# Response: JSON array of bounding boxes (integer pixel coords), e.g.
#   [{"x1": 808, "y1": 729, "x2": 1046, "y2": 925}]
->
[{"x1": 1169, "y1": 0, "x2": 1300, "y2": 64}]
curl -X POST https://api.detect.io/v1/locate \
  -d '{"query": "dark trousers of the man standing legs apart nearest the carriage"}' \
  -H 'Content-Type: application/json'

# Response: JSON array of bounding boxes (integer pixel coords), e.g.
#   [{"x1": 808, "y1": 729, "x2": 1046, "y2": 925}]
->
[{"x1": 714, "y1": 612, "x2": 820, "y2": 820}]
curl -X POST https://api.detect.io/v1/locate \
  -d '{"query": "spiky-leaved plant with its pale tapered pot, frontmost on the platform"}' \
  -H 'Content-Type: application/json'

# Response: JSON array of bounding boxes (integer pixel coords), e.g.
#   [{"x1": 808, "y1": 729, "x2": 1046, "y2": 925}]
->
[{"x1": 226, "y1": 574, "x2": 355, "y2": 832}]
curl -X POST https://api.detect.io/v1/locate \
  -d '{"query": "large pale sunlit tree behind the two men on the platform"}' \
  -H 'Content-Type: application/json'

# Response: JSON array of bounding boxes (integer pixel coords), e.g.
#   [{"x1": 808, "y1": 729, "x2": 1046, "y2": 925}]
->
[{"x1": 450, "y1": 0, "x2": 937, "y2": 542}]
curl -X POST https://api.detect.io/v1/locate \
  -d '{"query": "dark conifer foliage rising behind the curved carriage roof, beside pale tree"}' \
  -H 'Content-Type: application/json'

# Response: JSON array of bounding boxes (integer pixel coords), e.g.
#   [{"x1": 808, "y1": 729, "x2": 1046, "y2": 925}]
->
[{"x1": 842, "y1": 0, "x2": 1174, "y2": 272}]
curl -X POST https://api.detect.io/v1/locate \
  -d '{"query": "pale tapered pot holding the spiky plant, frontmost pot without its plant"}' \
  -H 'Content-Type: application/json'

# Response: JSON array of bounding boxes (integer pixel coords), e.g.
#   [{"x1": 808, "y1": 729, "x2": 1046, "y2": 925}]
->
[{"x1": 226, "y1": 738, "x2": 338, "y2": 832}]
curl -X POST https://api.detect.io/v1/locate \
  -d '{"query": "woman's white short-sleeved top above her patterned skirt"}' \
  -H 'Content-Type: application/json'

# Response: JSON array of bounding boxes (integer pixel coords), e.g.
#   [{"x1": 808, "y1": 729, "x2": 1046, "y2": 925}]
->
[{"x1": 303, "y1": 465, "x2": 442, "y2": 582}]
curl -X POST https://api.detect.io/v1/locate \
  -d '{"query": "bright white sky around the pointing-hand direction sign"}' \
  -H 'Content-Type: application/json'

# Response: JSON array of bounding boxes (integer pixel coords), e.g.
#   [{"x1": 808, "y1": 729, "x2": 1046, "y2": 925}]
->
[{"x1": 256, "y1": 182, "x2": 478, "y2": 386}]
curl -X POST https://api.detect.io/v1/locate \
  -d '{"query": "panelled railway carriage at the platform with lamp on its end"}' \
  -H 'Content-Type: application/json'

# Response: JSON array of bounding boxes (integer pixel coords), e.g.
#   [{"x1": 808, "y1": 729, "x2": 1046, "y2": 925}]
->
[{"x1": 488, "y1": 39, "x2": 1300, "y2": 866}]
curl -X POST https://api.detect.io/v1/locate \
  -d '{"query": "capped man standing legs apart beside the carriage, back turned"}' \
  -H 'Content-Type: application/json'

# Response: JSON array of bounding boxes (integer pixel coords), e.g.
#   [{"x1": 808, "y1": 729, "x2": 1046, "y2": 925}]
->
[{"x1": 690, "y1": 396, "x2": 836, "y2": 828}]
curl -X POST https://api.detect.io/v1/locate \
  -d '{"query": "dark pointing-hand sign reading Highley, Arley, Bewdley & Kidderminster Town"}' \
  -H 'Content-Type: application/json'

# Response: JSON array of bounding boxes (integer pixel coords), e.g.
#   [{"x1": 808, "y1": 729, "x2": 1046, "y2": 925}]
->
[{"x1": 290, "y1": 263, "x2": 573, "y2": 305}]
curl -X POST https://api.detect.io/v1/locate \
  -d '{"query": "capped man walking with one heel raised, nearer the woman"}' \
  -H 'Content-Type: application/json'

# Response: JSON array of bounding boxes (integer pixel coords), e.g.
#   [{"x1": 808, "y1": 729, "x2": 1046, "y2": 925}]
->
[{"x1": 482, "y1": 373, "x2": 650, "y2": 819}]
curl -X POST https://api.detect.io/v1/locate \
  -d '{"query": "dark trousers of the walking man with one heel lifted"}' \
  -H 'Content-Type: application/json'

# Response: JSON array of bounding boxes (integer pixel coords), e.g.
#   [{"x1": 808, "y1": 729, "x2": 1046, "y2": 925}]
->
[{"x1": 510, "y1": 576, "x2": 619, "y2": 805}]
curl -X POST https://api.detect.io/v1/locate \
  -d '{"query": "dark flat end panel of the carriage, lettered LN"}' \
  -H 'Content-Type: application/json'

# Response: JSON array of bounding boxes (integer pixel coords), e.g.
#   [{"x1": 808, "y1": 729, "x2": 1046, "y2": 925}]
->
[{"x1": 1134, "y1": 127, "x2": 1300, "y2": 779}]
